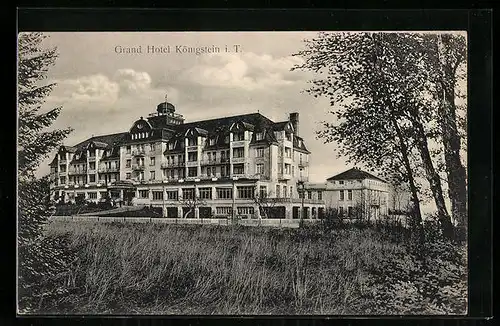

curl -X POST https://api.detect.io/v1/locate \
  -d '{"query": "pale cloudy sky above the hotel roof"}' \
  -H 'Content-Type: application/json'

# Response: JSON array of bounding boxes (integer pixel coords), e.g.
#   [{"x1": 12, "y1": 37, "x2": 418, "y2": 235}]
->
[{"x1": 40, "y1": 32, "x2": 350, "y2": 182}]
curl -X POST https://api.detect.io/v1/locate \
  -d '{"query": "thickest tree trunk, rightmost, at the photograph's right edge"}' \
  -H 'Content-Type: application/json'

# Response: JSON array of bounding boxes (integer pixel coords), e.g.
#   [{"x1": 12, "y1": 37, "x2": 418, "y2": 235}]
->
[{"x1": 438, "y1": 35, "x2": 467, "y2": 227}]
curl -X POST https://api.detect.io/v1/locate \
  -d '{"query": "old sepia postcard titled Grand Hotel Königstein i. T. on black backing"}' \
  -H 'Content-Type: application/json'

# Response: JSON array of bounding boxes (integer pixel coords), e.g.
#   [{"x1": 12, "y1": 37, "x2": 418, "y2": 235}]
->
[{"x1": 17, "y1": 30, "x2": 468, "y2": 316}]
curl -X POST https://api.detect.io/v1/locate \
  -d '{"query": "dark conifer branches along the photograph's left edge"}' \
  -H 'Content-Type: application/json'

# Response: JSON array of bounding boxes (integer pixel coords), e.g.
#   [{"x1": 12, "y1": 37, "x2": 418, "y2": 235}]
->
[{"x1": 17, "y1": 33, "x2": 72, "y2": 312}]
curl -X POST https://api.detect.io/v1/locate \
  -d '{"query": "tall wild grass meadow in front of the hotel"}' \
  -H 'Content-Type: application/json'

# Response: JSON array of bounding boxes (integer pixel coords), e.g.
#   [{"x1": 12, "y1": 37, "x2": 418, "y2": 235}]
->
[{"x1": 31, "y1": 221, "x2": 467, "y2": 315}]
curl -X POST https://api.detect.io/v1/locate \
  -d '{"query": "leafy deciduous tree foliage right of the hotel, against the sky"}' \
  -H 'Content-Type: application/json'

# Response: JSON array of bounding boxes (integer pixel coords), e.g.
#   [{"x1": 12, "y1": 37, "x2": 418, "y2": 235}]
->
[{"x1": 293, "y1": 32, "x2": 465, "y2": 238}]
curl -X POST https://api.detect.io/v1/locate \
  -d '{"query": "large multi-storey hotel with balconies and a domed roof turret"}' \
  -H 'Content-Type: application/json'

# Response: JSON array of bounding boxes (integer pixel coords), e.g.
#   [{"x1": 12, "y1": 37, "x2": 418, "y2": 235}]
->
[{"x1": 50, "y1": 99, "x2": 324, "y2": 218}]
